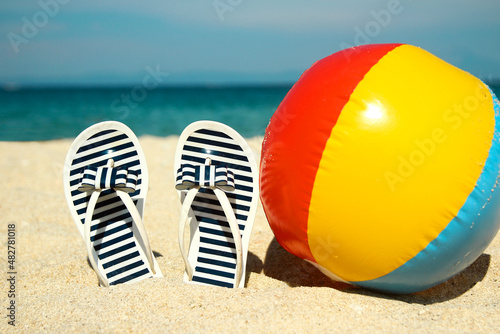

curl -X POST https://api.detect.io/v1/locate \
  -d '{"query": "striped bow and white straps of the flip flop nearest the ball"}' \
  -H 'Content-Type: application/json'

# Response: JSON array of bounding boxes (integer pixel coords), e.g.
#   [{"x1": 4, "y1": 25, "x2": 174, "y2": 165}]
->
[{"x1": 175, "y1": 159, "x2": 243, "y2": 288}]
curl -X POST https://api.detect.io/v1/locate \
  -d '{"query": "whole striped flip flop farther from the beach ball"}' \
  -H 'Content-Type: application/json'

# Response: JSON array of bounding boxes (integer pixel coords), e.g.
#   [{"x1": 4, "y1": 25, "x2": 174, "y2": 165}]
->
[{"x1": 63, "y1": 121, "x2": 162, "y2": 286}]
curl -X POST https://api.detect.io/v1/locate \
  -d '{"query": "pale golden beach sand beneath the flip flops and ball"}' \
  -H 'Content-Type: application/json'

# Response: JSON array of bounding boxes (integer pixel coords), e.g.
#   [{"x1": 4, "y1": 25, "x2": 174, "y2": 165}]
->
[{"x1": 0, "y1": 137, "x2": 500, "y2": 333}]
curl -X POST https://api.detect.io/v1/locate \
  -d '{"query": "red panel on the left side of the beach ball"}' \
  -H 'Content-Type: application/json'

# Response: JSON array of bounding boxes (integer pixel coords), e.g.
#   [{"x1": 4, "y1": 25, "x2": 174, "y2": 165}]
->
[{"x1": 260, "y1": 44, "x2": 401, "y2": 261}]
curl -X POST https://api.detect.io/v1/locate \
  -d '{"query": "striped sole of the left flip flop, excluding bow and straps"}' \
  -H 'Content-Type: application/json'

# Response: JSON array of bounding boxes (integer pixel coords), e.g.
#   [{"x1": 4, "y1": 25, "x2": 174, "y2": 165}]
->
[{"x1": 63, "y1": 121, "x2": 162, "y2": 285}]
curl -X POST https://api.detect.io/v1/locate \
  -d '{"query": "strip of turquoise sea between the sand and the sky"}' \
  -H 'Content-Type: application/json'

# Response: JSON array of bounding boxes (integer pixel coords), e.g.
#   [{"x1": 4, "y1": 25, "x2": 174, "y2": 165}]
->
[{"x1": 0, "y1": 82, "x2": 500, "y2": 141}]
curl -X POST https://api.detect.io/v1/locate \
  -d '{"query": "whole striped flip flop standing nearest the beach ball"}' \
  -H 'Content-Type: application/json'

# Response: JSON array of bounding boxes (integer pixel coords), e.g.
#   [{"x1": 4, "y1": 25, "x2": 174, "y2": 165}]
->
[{"x1": 174, "y1": 121, "x2": 259, "y2": 288}]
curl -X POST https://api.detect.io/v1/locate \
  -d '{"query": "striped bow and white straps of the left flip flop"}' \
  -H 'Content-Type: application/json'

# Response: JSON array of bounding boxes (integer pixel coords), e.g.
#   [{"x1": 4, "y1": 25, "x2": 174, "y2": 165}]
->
[{"x1": 78, "y1": 159, "x2": 155, "y2": 286}]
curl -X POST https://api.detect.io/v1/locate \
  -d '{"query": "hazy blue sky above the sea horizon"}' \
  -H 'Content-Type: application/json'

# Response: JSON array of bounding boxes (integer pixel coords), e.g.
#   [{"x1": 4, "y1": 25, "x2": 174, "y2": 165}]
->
[{"x1": 0, "y1": 0, "x2": 500, "y2": 86}]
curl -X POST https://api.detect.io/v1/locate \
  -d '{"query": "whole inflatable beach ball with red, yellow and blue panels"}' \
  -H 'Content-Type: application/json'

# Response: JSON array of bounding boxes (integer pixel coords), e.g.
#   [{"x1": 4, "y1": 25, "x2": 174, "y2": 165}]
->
[{"x1": 260, "y1": 44, "x2": 500, "y2": 293}]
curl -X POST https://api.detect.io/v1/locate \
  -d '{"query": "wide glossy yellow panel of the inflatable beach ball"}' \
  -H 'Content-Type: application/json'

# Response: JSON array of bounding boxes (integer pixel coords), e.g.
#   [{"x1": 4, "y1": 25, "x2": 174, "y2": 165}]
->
[{"x1": 307, "y1": 45, "x2": 495, "y2": 282}]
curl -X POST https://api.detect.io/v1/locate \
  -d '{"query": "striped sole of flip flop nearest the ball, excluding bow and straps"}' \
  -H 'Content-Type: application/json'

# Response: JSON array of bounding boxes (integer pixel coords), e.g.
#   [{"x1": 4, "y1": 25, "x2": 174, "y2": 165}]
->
[{"x1": 174, "y1": 121, "x2": 259, "y2": 288}]
